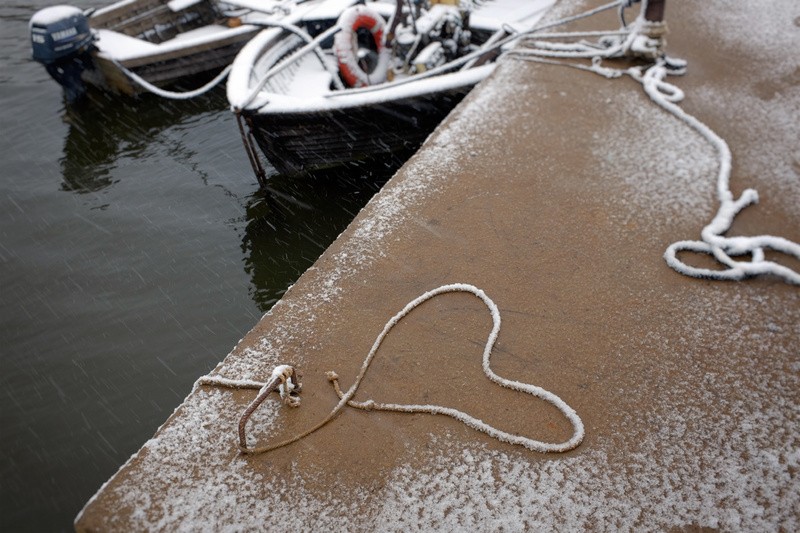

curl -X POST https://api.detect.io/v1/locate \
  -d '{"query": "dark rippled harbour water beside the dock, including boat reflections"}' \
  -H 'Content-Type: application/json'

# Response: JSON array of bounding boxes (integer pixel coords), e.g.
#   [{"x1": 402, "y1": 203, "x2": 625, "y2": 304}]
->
[{"x1": 0, "y1": 0, "x2": 386, "y2": 531}]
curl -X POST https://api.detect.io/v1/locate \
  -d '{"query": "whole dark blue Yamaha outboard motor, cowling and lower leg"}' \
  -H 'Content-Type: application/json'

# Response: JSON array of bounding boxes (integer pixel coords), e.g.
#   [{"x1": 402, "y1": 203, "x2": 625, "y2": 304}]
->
[{"x1": 30, "y1": 6, "x2": 95, "y2": 102}]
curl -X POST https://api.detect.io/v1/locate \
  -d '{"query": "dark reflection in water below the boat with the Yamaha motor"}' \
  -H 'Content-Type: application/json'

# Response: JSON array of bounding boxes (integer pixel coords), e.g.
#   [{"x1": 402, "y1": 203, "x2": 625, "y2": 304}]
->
[{"x1": 60, "y1": 91, "x2": 228, "y2": 193}]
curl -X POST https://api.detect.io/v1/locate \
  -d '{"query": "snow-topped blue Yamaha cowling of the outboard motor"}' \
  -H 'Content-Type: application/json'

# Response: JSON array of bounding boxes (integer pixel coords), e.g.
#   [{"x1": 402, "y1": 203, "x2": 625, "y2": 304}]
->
[{"x1": 30, "y1": 5, "x2": 95, "y2": 65}]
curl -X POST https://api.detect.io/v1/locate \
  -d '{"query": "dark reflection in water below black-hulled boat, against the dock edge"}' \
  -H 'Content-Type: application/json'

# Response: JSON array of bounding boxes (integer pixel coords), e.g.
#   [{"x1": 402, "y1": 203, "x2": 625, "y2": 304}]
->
[{"x1": 242, "y1": 169, "x2": 393, "y2": 312}]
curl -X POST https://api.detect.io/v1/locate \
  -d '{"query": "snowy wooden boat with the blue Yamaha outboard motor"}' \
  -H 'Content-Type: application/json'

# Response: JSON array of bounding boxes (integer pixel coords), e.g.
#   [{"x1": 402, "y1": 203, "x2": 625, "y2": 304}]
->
[{"x1": 30, "y1": 0, "x2": 326, "y2": 100}]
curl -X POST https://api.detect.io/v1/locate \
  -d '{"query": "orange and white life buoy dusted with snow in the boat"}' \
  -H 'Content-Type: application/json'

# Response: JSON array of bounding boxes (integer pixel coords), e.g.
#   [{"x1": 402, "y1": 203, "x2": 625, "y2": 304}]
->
[{"x1": 333, "y1": 5, "x2": 389, "y2": 87}]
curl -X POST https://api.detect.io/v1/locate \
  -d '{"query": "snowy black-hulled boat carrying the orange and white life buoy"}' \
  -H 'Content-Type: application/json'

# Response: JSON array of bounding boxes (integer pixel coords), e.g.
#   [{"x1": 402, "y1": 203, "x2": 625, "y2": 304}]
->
[{"x1": 227, "y1": 0, "x2": 554, "y2": 181}]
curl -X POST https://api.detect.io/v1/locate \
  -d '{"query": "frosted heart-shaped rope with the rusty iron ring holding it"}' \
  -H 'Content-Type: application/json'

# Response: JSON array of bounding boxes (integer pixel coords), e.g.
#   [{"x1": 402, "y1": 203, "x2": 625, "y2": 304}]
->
[{"x1": 196, "y1": 283, "x2": 584, "y2": 454}]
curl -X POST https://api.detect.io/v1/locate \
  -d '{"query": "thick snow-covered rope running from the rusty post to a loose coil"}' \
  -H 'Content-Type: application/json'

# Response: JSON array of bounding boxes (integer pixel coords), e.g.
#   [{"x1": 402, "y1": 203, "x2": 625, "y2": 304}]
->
[{"x1": 507, "y1": 3, "x2": 800, "y2": 285}]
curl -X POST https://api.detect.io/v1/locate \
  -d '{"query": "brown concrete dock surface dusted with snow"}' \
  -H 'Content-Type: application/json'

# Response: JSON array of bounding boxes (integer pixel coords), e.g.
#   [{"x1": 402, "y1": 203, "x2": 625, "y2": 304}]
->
[{"x1": 76, "y1": 0, "x2": 800, "y2": 531}]
